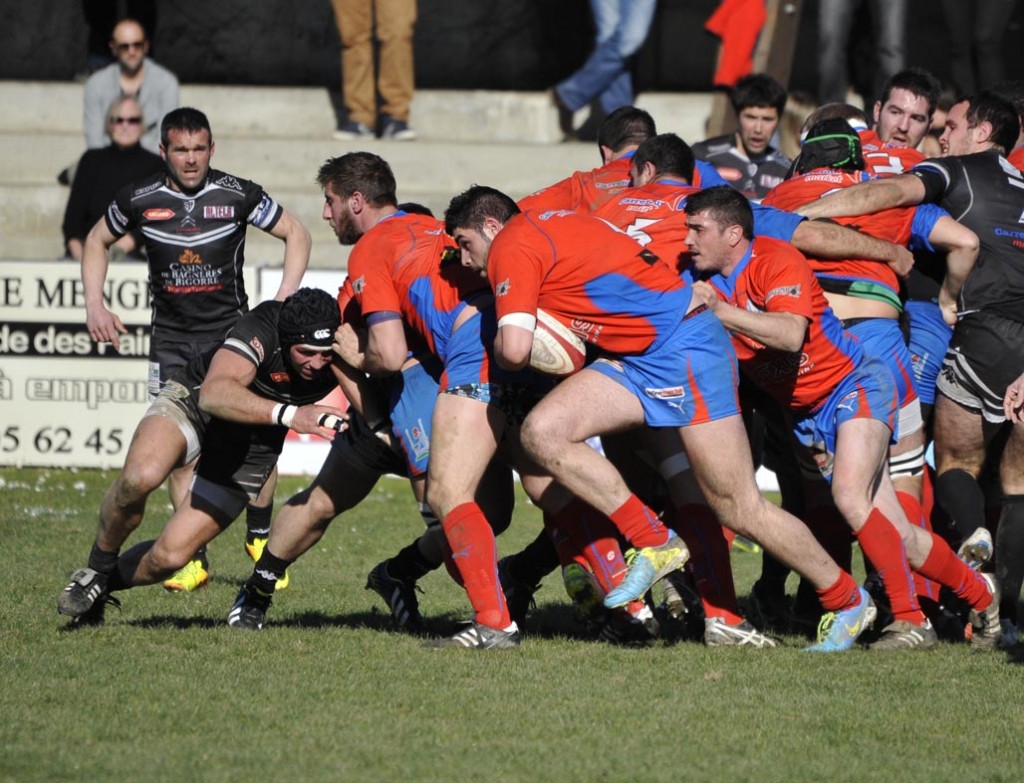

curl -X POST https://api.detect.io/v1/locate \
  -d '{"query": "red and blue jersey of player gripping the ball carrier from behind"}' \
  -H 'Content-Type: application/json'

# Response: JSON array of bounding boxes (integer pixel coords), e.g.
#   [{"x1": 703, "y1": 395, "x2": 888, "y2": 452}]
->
[{"x1": 686, "y1": 236, "x2": 863, "y2": 412}]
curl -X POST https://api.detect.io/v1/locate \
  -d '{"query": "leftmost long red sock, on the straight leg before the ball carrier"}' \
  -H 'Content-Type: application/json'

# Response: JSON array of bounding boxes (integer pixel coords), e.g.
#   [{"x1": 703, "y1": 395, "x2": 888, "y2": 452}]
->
[{"x1": 441, "y1": 503, "x2": 512, "y2": 628}]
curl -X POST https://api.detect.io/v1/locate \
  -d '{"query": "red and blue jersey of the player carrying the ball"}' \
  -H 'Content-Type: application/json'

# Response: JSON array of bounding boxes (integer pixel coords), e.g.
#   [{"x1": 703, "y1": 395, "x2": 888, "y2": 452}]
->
[{"x1": 487, "y1": 207, "x2": 691, "y2": 355}]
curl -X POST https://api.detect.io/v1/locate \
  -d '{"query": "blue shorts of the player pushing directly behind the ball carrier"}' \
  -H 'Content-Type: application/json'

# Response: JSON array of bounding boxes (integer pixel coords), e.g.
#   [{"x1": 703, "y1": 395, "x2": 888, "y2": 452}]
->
[{"x1": 793, "y1": 358, "x2": 899, "y2": 482}]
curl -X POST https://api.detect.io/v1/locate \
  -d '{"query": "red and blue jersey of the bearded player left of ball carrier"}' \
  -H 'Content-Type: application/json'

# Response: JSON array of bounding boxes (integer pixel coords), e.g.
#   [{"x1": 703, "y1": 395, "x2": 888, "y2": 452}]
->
[{"x1": 348, "y1": 212, "x2": 490, "y2": 360}]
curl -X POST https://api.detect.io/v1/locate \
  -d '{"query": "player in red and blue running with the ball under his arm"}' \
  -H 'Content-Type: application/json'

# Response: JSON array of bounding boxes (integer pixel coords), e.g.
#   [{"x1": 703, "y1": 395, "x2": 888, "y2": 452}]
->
[{"x1": 445, "y1": 186, "x2": 873, "y2": 651}]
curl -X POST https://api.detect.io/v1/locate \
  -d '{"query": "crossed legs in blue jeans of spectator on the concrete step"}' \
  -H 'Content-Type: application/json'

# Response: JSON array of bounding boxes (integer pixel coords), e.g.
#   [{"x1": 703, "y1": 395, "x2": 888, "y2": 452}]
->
[{"x1": 554, "y1": 0, "x2": 657, "y2": 138}]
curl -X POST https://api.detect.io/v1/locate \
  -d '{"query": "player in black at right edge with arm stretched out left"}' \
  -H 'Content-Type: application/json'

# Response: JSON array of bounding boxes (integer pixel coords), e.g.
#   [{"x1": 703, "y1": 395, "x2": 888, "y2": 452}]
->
[{"x1": 801, "y1": 92, "x2": 1024, "y2": 642}]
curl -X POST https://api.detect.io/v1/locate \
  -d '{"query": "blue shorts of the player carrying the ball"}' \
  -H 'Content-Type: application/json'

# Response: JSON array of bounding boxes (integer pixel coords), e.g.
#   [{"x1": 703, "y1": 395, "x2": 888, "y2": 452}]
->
[{"x1": 587, "y1": 310, "x2": 739, "y2": 427}]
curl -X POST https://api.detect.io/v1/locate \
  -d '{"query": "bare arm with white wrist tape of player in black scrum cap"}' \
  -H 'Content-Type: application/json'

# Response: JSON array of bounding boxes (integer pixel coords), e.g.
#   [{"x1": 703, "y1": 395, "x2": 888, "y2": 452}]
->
[{"x1": 199, "y1": 348, "x2": 347, "y2": 440}]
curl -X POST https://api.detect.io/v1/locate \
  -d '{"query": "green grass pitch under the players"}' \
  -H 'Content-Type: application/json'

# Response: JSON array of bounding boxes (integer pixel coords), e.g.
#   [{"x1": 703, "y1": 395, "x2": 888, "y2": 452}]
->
[{"x1": 0, "y1": 470, "x2": 1024, "y2": 783}]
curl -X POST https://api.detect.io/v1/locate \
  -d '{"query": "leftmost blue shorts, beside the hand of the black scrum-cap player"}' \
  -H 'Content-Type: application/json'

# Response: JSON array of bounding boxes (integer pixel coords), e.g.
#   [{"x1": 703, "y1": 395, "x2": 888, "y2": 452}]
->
[{"x1": 389, "y1": 357, "x2": 440, "y2": 476}]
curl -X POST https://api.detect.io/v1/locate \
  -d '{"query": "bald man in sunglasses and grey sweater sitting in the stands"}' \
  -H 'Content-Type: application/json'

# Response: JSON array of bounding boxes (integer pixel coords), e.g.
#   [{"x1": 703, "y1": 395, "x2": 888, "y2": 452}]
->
[{"x1": 82, "y1": 18, "x2": 178, "y2": 153}]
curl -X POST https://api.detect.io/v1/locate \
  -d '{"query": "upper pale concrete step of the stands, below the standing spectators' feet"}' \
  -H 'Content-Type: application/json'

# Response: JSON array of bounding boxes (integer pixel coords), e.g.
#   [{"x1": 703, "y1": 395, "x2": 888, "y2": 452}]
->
[{"x1": 0, "y1": 81, "x2": 711, "y2": 144}]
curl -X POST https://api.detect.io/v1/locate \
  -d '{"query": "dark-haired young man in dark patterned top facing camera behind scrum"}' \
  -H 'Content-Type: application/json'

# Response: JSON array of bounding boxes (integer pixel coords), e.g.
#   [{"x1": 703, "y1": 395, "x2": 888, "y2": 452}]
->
[{"x1": 693, "y1": 74, "x2": 790, "y2": 201}]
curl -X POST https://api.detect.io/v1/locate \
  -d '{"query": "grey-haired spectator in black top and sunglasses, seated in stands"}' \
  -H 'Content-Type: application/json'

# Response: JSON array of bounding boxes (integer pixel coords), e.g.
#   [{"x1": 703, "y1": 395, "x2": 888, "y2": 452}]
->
[{"x1": 63, "y1": 96, "x2": 164, "y2": 261}]
